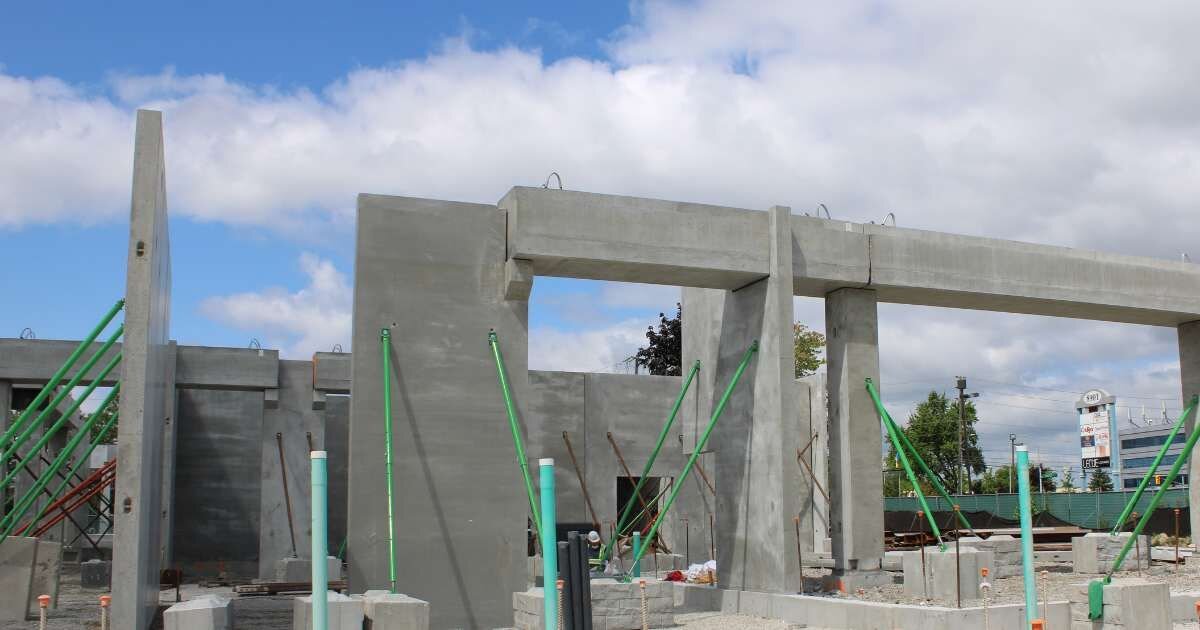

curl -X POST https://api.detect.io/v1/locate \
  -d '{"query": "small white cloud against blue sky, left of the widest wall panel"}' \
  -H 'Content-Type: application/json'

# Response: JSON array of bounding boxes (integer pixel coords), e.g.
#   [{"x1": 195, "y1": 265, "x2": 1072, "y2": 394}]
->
[{"x1": 200, "y1": 253, "x2": 353, "y2": 359}]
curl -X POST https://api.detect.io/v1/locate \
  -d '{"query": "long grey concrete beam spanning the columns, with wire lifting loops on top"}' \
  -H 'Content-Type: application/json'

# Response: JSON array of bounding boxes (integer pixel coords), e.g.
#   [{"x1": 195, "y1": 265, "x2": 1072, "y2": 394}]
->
[{"x1": 500, "y1": 187, "x2": 1200, "y2": 326}]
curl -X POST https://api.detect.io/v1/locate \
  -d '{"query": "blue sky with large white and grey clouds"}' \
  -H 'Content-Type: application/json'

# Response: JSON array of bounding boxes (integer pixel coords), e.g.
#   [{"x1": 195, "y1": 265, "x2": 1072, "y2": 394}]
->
[{"x1": 0, "y1": 0, "x2": 1200, "y2": 479}]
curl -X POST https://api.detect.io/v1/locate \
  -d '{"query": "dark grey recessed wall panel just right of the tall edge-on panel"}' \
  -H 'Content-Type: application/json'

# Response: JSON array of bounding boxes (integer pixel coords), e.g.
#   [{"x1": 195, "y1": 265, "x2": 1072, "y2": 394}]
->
[{"x1": 172, "y1": 389, "x2": 264, "y2": 578}]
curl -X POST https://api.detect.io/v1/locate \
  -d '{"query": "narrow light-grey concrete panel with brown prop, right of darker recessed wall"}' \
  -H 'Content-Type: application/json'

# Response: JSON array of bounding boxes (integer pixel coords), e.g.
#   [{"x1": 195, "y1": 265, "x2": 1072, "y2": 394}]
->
[{"x1": 258, "y1": 361, "x2": 324, "y2": 578}]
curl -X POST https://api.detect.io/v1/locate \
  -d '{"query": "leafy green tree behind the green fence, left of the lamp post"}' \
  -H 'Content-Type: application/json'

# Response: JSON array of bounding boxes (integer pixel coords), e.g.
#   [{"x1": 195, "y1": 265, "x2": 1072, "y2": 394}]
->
[{"x1": 888, "y1": 391, "x2": 984, "y2": 492}]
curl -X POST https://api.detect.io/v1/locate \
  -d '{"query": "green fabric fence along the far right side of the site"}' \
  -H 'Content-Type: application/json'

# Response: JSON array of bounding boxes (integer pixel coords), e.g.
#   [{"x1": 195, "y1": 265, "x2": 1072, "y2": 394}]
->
[{"x1": 883, "y1": 488, "x2": 1188, "y2": 529}]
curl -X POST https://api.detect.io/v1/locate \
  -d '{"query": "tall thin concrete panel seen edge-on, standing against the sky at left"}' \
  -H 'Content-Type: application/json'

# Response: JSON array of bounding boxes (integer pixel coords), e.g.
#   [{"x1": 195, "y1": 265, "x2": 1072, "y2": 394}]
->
[{"x1": 113, "y1": 109, "x2": 175, "y2": 630}]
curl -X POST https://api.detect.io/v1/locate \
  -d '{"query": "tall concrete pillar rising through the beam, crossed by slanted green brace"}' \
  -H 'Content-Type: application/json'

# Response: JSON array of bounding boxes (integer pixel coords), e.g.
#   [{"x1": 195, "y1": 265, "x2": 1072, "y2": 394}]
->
[{"x1": 683, "y1": 206, "x2": 808, "y2": 592}]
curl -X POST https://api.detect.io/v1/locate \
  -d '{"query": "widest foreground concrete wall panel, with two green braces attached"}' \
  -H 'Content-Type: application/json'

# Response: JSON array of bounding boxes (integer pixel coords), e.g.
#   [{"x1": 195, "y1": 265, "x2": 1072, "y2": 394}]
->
[{"x1": 347, "y1": 194, "x2": 540, "y2": 628}]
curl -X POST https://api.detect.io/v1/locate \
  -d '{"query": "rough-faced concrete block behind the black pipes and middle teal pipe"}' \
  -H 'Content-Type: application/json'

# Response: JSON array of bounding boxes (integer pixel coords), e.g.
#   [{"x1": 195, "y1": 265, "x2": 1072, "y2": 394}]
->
[{"x1": 512, "y1": 580, "x2": 676, "y2": 630}]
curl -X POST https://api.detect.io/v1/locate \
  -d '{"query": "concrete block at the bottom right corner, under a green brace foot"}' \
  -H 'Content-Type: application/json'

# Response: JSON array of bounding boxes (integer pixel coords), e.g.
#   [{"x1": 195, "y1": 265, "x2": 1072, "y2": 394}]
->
[{"x1": 1070, "y1": 577, "x2": 1171, "y2": 630}]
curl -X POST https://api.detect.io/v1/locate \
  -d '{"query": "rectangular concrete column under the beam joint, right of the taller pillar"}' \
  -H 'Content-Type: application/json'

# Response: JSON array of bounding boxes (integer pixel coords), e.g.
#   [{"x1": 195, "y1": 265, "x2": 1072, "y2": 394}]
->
[{"x1": 826, "y1": 288, "x2": 883, "y2": 572}]
